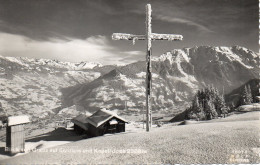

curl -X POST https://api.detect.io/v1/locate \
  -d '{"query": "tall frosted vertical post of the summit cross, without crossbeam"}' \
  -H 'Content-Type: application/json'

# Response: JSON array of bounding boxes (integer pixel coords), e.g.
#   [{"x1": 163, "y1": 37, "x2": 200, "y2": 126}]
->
[{"x1": 146, "y1": 4, "x2": 152, "y2": 132}]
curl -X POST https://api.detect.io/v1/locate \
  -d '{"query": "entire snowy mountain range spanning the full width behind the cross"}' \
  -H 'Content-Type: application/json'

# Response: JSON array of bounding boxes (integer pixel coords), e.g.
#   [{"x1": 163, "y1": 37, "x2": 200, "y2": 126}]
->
[{"x1": 0, "y1": 46, "x2": 260, "y2": 119}]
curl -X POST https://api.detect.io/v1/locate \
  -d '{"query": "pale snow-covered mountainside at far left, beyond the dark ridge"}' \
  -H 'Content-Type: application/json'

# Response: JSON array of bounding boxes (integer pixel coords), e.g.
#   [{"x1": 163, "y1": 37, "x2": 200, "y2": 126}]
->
[{"x1": 0, "y1": 56, "x2": 104, "y2": 121}]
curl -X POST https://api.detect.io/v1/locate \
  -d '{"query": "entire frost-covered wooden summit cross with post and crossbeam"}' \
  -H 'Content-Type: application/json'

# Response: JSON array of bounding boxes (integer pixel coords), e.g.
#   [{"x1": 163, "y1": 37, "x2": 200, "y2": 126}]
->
[{"x1": 112, "y1": 4, "x2": 183, "y2": 132}]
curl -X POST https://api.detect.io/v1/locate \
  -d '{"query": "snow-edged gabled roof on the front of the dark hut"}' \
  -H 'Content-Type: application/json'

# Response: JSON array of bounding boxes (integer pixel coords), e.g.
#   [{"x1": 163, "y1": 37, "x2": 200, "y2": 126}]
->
[{"x1": 86, "y1": 109, "x2": 127, "y2": 127}]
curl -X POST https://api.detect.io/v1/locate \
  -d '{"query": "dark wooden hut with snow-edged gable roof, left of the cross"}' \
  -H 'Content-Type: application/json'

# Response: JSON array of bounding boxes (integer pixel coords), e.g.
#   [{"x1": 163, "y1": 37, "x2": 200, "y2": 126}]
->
[{"x1": 72, "y1": 109, "x2": 127, "y2": 136}]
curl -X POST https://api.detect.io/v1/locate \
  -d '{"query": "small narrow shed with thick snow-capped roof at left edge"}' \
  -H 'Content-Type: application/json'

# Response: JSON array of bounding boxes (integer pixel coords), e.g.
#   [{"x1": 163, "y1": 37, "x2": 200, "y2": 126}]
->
[{"x1": 6, "y1": 115, "x2": 30, "y2": 154}]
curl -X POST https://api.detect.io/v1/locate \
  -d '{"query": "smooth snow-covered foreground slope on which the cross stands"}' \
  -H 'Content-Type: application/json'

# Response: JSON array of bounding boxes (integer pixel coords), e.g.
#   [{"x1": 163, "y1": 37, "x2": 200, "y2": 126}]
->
[{"x1": 1, "y1": 112, "x2": 260, "y2": 164}]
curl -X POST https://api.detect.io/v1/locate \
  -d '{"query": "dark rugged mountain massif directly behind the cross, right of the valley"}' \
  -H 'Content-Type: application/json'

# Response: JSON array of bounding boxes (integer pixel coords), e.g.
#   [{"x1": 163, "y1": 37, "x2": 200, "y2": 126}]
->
[{"x1": 62, "y1": 46, "x2": 259, "y2": 113}]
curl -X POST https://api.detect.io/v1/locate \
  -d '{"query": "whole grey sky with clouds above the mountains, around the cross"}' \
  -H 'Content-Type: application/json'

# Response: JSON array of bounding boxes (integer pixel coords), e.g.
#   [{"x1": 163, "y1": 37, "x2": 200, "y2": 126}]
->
[{"x1": 0, "y1": 0, "x2": 259, "y2": 65}]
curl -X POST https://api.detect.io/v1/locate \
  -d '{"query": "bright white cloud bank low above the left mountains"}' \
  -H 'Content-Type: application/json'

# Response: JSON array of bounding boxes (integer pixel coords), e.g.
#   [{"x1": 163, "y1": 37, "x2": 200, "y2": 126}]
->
[{"x1": 0, "y1": 33, "x2": 144, "y2": 65}]
